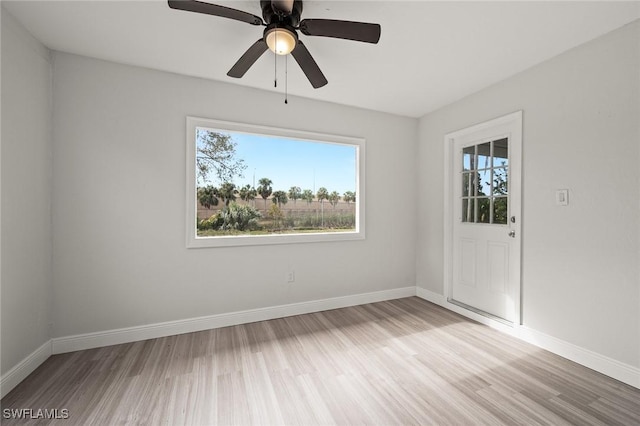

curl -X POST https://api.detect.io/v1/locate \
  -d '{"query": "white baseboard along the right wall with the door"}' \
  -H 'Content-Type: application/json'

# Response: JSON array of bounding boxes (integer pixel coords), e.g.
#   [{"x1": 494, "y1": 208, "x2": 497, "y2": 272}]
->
[{"x1": 416, "y1": 287, "x2": 640, "y2": 389}]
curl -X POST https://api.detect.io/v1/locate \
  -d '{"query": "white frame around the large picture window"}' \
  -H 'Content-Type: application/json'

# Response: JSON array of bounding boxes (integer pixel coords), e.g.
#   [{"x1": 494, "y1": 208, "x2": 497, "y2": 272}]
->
[{"x1": 186, "y1": 117, "x2": 365, "y2": 248}]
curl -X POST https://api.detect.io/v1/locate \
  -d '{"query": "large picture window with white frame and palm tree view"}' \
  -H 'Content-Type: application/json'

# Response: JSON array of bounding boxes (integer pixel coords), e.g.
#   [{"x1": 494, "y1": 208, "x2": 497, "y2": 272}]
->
[{"x1": 187, "y1": 117, "x2": 364, "y2": 247}]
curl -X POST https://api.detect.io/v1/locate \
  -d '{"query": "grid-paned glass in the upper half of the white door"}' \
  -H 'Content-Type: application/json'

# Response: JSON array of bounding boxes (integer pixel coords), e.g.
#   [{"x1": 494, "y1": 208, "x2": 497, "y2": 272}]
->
[{"x1": 461, "y1": 138, "x2": 509, "y2": 225}]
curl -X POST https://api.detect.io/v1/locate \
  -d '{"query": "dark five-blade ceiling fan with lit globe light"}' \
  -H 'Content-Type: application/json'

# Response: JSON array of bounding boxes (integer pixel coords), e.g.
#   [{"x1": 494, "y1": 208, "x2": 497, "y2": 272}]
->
[{"x1": 169, "y1": 0, "x2": 380, "y2": 89}]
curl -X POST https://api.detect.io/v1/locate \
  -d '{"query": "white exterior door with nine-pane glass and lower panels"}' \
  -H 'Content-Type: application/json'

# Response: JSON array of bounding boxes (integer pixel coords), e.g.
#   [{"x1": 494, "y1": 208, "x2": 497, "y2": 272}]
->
[{"x1": 447, "y1": 112, "x2": 522, "y2": 323}]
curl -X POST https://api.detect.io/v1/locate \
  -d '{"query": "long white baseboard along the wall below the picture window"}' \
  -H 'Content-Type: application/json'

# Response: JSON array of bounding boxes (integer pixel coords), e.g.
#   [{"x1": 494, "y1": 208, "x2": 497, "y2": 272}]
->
[{"x1": 52, "y1": 287, "x2": 416, "y2": 354}]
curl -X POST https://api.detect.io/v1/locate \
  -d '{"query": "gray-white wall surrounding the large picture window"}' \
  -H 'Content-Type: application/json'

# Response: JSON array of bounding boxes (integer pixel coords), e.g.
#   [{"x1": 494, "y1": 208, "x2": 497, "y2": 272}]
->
[{"x1": 53, "y1": 53, "x2": 418, "y2": 337}]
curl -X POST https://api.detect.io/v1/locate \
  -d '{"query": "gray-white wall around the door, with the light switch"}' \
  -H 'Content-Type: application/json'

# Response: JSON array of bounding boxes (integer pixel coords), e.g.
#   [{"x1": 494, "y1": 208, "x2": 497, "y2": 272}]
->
[{"x1": 416, "y1": 21, "x2": 640, "y2": 367}]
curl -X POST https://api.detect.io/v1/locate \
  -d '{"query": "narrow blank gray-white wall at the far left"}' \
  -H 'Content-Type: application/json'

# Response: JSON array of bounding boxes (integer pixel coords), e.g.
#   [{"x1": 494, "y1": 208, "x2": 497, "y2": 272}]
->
[{"x1": 0, "y1": 10, "x2": 52, "y2": 375}]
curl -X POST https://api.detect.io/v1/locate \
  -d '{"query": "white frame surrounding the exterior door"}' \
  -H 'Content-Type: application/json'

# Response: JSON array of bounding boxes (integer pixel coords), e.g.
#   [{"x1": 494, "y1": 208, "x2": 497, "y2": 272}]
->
[{"x1": 444, "y1": 110, "x2": 523, "y2": 326}]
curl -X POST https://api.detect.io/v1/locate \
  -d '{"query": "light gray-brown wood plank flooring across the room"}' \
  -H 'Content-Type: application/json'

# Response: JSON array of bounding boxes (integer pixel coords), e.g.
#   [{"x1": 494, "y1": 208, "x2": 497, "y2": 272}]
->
[{"x1": 2, "y1": 297, "x2": 640, "y2": 425}]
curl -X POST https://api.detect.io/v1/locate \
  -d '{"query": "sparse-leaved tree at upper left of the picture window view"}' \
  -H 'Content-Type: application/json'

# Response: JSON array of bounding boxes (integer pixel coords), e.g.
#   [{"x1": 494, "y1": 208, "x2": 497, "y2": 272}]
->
[{"x1": 196, "y1": 129, "x2": 247, "y2": 182}]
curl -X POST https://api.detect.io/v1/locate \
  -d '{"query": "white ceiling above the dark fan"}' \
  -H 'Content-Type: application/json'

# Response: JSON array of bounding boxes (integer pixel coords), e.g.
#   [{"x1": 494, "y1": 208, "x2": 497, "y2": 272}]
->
[{"x1": 2, "y1": 0, "x2": 640, "y2": 117}]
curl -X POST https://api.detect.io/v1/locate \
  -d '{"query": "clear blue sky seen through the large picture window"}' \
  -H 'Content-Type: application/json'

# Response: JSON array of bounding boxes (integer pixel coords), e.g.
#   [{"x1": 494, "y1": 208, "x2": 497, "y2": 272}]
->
[{"x1": 200, "y1": 132, "x2": 356, "y2": 196}]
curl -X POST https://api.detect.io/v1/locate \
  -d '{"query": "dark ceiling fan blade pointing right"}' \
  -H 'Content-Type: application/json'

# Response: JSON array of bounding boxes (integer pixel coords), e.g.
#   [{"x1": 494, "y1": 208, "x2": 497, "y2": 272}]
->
[{"x1": 300, "y1": 19, "x2": 381, "y2": 44}]
